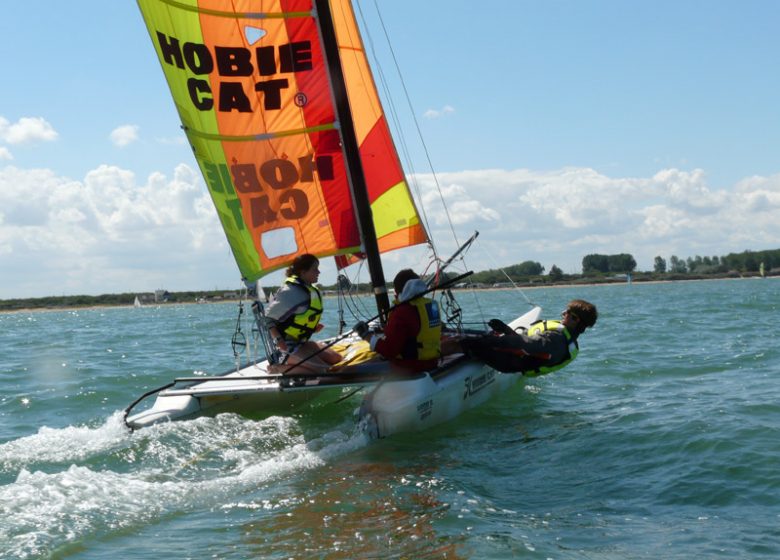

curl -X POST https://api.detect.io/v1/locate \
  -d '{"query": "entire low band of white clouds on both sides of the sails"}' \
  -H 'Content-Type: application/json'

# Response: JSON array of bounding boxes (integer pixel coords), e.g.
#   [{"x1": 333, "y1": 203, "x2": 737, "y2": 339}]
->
[{"x1": 0, "y1": 164, "x2": 780, "y2": 299}]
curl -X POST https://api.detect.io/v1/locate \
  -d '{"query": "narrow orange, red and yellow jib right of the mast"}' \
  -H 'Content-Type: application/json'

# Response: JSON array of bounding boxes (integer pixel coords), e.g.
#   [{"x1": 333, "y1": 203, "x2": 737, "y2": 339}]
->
[{"x1": 330, "y1": 0, "x2": 428, "y2": 252}]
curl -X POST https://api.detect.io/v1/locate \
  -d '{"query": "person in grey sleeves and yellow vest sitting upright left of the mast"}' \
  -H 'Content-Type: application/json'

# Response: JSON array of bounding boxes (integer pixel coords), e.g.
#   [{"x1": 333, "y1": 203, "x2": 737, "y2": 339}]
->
[{"x1": 265, "y1": 253, "x2": 341, "y2": 371}]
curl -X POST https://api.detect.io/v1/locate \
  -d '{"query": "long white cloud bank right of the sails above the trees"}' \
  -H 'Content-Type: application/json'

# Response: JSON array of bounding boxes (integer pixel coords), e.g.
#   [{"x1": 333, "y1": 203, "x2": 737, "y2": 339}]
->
[{"x1": 406, "y1": 168, "x2": 780, "y2": 272}]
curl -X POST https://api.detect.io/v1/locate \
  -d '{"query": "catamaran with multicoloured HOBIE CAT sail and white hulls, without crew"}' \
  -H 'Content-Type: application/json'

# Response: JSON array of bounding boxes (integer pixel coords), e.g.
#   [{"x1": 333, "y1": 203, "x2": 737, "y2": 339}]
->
[{"x1": 125, "y1": 0, "x2": 541, "y2": 437}]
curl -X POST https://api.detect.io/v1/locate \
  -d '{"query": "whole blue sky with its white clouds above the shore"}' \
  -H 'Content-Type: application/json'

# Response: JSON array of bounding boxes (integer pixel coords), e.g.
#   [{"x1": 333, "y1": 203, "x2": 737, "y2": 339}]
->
[{"x1": 0, "y1": 0, "x2": 780, "y2": 299}]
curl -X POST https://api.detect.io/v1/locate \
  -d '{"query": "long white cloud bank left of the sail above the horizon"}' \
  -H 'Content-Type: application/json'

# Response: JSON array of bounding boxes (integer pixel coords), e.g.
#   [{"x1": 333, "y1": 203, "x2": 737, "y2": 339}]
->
[{"x1": 0, "y1": 164, "x2": 229, "y2": 299}]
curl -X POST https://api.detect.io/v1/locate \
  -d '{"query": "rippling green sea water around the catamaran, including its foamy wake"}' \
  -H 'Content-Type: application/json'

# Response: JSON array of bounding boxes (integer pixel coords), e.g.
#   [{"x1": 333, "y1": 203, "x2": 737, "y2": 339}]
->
[{"x1": 0, "y1": 279, "x2": 780, "y2": 560}]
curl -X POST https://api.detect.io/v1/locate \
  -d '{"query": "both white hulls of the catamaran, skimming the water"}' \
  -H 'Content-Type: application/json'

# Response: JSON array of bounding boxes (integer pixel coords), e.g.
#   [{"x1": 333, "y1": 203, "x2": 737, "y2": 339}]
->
[{"x1": 126, "y1": 307, "x2": 541, "y2": 437}]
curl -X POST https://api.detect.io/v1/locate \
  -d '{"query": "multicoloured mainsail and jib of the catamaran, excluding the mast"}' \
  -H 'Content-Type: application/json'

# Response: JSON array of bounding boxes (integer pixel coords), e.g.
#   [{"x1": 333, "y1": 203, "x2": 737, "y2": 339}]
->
[{"x1": 138, "y1": 0, "x2": 427, "y2": 281}]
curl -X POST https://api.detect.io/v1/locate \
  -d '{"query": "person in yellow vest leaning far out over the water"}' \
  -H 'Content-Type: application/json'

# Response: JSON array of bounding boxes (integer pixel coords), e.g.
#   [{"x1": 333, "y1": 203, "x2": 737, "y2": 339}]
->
[{"x1": 460, "y1": 299, "x2": 598, "y2": 377}]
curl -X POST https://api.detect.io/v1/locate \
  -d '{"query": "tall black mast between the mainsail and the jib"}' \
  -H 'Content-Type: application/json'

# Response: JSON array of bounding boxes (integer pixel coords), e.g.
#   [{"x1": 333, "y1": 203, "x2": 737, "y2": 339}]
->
[{"x1": 314, "y1": 0, "x2": 390, "y2": 324}]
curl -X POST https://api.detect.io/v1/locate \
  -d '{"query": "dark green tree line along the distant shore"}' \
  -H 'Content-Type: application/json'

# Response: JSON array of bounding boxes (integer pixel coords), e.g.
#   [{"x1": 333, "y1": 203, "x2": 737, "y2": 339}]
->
[{"x1": 0, "y1": 249, "x2": 780, "y2": 311}]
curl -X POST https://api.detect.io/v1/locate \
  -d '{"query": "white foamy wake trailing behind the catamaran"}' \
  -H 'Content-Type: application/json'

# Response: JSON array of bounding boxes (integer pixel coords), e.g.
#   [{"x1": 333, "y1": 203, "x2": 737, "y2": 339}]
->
[{"x1": 0, "y1": 412, "x2": 369, "y2": 558}]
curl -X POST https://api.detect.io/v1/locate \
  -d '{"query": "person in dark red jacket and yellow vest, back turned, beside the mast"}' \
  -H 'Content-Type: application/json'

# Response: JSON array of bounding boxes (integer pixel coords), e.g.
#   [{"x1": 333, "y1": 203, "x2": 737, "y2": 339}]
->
[{"x1": 353, "y1": 268, "x2": 441, "y2": 372}]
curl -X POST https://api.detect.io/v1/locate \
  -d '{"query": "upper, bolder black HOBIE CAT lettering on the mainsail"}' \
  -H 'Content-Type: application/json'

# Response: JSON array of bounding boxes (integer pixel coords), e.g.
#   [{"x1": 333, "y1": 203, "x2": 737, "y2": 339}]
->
[{"x1": 157, "y1": 32, "x2": 314, "y2": 113}]
